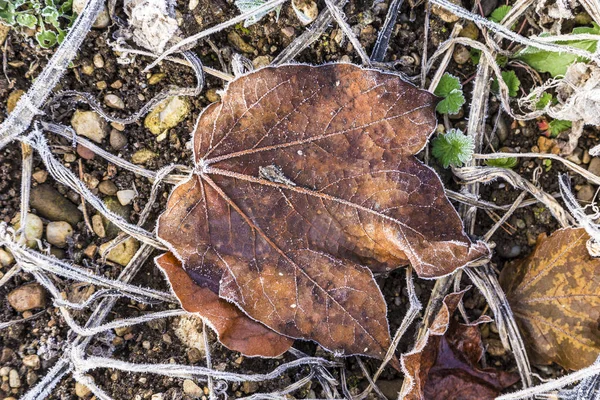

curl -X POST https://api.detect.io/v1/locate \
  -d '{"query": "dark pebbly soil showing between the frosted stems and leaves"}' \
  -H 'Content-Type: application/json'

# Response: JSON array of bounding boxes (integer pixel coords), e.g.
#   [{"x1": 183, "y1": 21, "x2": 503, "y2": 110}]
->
[{"x1": 0, "y1": 0, "x2": 597, "y2": 400}]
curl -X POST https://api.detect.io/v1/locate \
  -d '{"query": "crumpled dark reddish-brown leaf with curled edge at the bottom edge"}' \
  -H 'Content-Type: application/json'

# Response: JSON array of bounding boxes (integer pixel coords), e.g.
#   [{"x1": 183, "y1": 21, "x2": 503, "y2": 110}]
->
[{"x1": 399, "y1": 291, "x2": 519, "y2": 400}]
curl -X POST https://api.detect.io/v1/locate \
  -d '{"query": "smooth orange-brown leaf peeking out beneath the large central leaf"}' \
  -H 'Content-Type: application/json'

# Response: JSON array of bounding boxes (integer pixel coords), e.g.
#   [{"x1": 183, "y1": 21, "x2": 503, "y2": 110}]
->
[{"x1": 155, "y1": 253, "x2": 293, "y2": 357}]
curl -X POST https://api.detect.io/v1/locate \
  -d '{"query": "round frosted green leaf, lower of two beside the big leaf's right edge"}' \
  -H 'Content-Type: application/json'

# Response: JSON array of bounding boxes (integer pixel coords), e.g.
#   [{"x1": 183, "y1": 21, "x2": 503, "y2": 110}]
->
[{"x1": 431, "y1": 129, "x2": 475, "y2": 168}]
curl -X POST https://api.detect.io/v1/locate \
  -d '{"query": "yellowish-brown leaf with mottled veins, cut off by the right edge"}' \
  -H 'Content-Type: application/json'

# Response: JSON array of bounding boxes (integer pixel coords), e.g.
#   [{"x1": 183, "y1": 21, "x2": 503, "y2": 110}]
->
[{"x1": 500, "y1": 228, "x2": 600, "y2": 370}]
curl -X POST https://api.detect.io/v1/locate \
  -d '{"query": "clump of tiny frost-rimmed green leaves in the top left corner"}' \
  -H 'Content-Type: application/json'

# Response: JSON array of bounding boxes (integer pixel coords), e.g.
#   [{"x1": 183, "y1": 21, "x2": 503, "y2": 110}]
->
[{"x1": 0, "y1": 0, "x2": 75, "y2": 49}]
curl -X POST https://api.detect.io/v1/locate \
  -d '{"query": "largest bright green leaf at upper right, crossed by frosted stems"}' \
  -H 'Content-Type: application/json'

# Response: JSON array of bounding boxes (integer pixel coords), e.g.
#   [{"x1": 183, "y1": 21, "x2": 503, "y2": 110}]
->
[{"x1": 515, "y1": 22, "x2": 600, "y2": 77}]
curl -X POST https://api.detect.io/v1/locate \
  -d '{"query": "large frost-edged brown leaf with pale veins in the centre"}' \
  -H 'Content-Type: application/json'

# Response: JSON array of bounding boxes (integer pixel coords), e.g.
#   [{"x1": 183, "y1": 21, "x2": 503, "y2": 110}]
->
[{"x1": 158, "y1": 64, "x2": 488, "y2": 357}]
